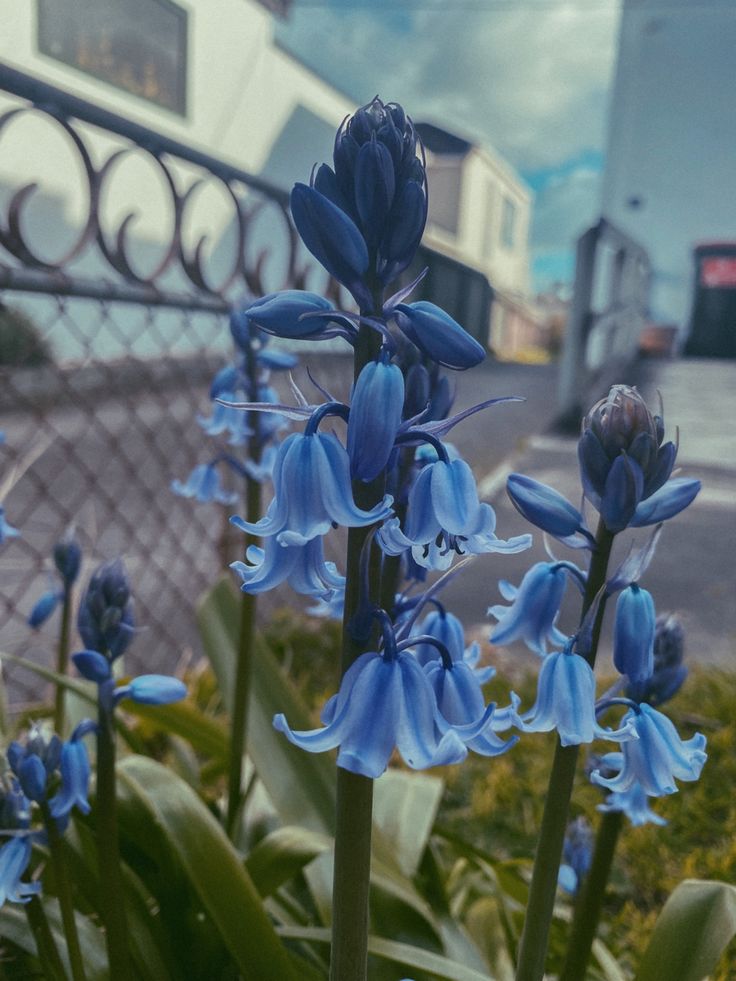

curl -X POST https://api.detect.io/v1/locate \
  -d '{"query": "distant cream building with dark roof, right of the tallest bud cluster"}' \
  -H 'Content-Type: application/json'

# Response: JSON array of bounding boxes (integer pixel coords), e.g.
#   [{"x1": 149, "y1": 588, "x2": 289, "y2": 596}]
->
[{"x1": 417, "y1": 123, "x2": 537, "y2": 356}]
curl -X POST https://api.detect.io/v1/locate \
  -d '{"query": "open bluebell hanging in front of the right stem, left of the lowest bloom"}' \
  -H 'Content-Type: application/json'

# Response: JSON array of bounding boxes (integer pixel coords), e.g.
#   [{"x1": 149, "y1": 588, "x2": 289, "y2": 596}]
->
[{"x1": 521, "y1": 647, "x2": 636, "y2": 746}]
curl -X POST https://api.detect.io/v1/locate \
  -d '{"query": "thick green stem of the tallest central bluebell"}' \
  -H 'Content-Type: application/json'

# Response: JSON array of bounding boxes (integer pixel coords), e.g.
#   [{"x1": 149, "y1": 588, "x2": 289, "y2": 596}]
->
[{"x1": 330, "y1": 310, "x2": 384, "y2": 981}]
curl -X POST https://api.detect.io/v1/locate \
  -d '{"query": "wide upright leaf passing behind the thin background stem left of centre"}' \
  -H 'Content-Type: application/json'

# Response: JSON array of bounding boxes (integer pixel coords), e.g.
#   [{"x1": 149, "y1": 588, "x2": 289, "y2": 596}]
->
[{"x1": 197, "y1": 579, "x2": 335, "y2": 834}]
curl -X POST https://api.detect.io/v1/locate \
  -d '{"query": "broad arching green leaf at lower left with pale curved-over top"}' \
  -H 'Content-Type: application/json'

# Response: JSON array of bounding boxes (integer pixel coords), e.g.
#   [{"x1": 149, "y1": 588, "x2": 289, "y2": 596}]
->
[{"x1": 118, "y1": 756, "x2": 295, "y2": 981}]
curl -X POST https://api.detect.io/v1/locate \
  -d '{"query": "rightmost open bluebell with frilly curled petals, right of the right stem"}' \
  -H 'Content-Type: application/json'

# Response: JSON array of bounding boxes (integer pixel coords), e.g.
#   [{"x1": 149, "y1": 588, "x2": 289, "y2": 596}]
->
[{"x1": 590, "y1": 702, "x2": 708, "y2": 797}]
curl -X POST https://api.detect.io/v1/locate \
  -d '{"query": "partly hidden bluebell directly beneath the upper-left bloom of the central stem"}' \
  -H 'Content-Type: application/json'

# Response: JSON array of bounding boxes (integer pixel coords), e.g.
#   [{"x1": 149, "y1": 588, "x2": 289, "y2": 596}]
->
[{"x1": 230, "y1": 536, "x2": 345, "y2": 602}]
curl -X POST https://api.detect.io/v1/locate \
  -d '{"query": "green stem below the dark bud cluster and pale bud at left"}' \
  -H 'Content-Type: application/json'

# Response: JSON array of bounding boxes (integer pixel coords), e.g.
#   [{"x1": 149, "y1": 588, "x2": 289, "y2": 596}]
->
[{"x1": 95, "y1": 705, "x2": 133, "y2": 981}]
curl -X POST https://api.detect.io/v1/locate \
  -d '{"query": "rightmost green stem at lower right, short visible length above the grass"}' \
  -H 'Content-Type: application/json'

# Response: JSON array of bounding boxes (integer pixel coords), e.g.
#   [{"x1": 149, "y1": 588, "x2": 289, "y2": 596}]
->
[{"x1": 559, "y1": 811, "x2": 624, "y2": 981}]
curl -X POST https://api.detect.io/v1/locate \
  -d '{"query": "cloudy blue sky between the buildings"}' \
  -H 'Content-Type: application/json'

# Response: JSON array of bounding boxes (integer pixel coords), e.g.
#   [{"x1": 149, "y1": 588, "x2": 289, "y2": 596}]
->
[{"x1": 277, "y1": 0, "x2": 619, "y2": 290}]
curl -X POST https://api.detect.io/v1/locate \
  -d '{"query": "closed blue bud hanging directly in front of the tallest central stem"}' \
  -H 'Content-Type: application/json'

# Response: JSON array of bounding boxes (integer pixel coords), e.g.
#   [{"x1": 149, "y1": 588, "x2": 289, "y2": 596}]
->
[{"x1": 347, "y1": 360, "x2": 404, "y2": 481}]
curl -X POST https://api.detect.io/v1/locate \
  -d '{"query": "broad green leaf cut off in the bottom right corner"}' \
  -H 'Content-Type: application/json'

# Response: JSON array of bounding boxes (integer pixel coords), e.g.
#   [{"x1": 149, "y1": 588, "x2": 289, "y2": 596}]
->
[{"x1": 636, "y1": 879, "x2": 736, "y2": 981}]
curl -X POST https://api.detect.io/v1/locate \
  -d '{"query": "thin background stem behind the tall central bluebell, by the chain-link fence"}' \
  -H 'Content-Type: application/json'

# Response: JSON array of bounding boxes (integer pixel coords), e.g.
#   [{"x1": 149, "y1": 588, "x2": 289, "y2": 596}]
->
[{"x1": 226, "y1": 350, "x2": 263, "y2": 838}]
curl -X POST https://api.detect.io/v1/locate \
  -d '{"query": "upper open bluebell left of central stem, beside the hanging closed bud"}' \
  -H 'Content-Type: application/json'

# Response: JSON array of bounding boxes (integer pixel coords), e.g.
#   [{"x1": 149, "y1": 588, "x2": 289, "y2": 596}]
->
[{"x1": 230, "y1": 431, "x2": 392, "y2": 545}]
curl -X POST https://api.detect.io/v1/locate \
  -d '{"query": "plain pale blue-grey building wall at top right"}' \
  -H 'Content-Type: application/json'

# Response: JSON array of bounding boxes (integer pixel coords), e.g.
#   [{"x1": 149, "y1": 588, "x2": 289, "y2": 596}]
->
[{"x1": 602, "y1": 0, "x2": 736, "y2": 328}]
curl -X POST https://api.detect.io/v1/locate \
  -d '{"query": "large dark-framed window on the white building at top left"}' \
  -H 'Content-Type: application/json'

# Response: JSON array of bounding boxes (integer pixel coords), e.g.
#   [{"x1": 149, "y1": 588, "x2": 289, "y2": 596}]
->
[{"x1": 38, "y1": 0, "x2": 187, "y2": 116}]
